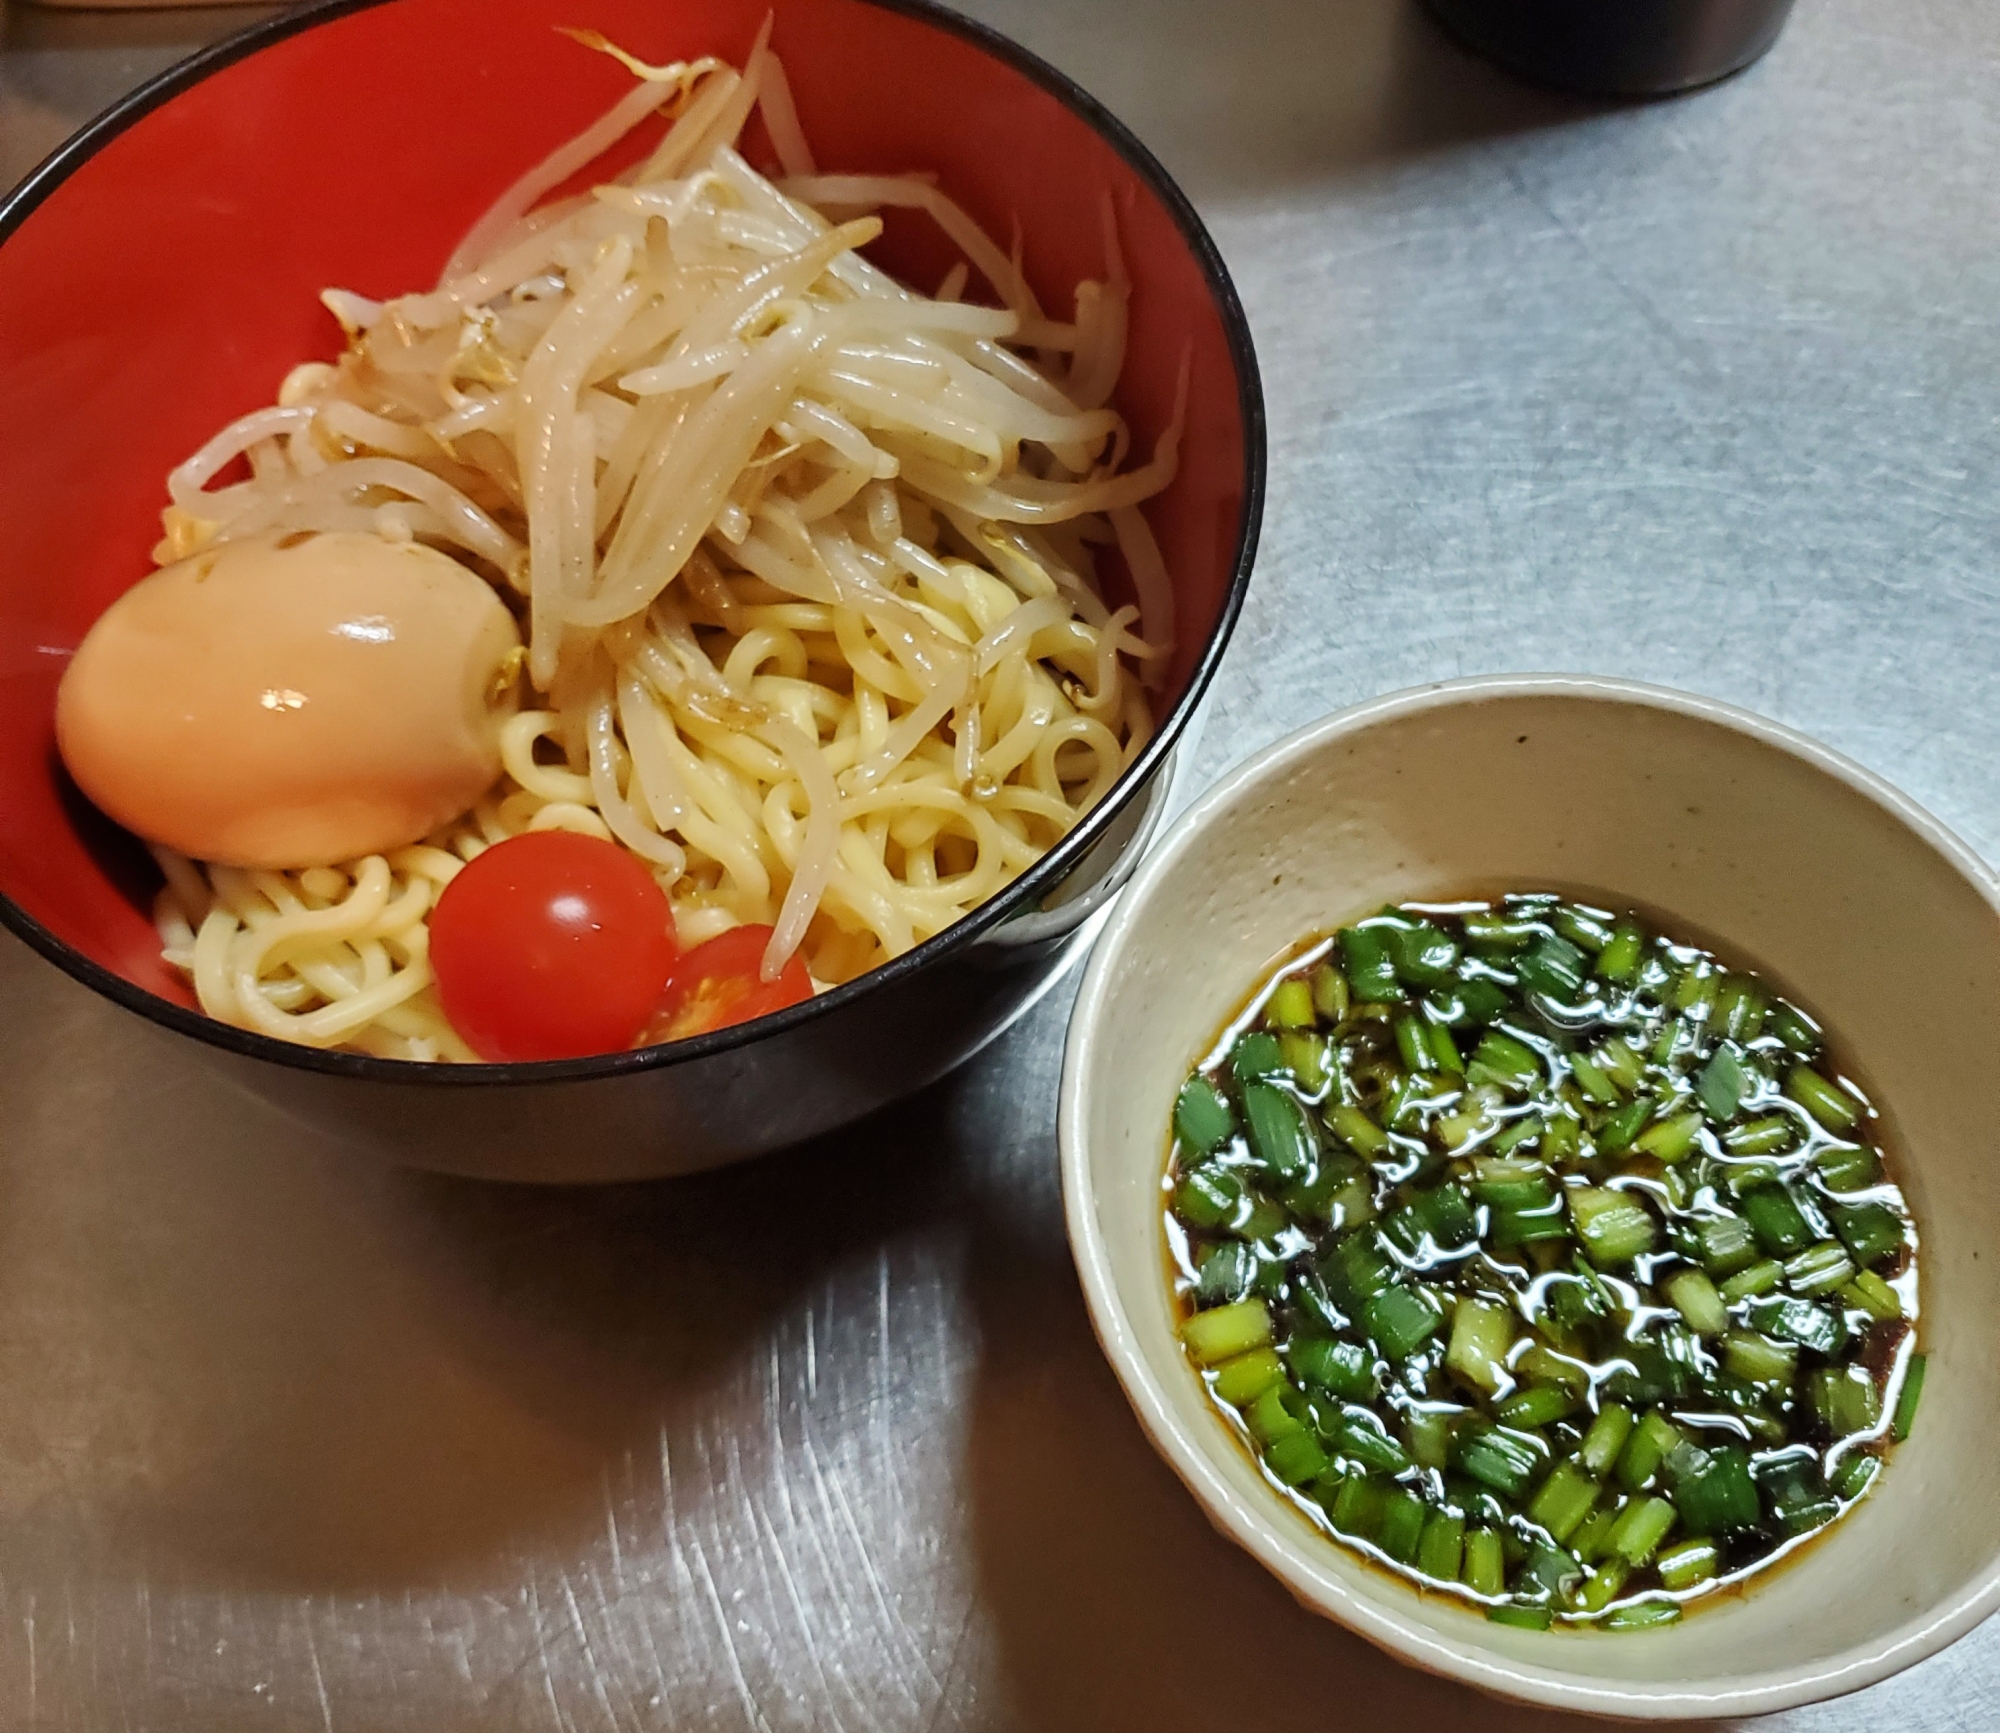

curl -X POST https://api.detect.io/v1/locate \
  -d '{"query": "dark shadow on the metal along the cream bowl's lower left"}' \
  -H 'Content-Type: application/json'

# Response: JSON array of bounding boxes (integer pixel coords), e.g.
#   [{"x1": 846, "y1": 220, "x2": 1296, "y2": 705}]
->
[{"x1": 962, "y1": 1115, "x2": 1720, "y2": 1733}]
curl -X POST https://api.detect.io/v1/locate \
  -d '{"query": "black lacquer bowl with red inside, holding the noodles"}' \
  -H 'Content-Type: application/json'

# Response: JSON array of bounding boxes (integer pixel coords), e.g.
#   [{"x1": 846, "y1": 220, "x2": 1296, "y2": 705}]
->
[{"x1": 0, "y1": 0, "x2": 1264, "y2": 1179}]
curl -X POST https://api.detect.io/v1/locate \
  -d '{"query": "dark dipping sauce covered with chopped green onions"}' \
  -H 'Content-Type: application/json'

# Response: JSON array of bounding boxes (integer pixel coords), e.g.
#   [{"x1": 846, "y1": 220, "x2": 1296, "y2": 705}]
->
[{"x1": 1166, "y1": 895, "x2": 1924, "y2": 1629}]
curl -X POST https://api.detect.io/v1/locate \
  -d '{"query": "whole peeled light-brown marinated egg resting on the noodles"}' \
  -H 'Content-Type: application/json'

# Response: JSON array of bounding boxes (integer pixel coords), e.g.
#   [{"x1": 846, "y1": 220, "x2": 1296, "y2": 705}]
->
[{"x1": 56, "y1": 534, "x2": 520, "y2": 869}]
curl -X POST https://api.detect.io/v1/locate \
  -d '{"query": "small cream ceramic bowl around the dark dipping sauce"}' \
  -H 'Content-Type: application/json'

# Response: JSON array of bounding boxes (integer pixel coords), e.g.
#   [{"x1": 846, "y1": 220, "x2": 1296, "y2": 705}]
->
[{"x1": 1062, "y1": 676, "x2": 2000, "y2": 1719}]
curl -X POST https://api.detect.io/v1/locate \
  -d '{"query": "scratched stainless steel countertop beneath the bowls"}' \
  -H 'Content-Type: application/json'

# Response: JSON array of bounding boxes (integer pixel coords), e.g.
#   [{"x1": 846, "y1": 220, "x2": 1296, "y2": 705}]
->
[{"x1": 0, "y1": 0, "x2": 2000, "y2": 1733}]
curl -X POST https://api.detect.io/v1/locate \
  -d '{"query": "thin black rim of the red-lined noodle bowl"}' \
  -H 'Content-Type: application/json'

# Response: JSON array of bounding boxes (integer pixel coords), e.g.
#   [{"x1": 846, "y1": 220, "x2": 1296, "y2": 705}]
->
[{"x1": 0, "y1": 0, "x2": 1266, "y2": 1089}]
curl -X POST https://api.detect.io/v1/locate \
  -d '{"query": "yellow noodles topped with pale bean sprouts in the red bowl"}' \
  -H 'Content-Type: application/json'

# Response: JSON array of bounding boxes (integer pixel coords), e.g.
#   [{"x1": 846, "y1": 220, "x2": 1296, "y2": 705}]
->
[{"x1": 156, "y1": 32, "x2": 1186, "y2": 1061}]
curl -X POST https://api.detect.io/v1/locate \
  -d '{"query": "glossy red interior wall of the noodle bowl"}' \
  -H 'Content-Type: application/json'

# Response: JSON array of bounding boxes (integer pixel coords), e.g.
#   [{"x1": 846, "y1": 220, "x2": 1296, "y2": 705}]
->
[{"x1": 0, "y1": 0, "x2": 1254, "y2": 1005}]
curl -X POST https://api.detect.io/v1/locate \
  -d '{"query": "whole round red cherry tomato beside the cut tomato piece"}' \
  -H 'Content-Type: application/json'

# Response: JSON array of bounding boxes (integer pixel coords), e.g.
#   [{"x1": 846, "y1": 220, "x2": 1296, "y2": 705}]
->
[{"x1": 430, "y1": 830, "x2": 680, "y2": 1063}]
